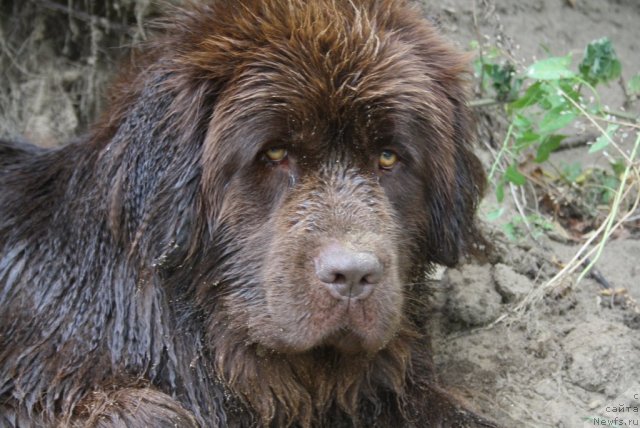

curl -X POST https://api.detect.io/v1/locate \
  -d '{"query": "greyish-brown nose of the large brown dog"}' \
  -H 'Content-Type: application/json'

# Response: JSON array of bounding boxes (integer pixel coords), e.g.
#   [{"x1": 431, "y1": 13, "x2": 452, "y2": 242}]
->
[{"x1": 315, "y1": 244, "x2": 383, "y2": 300}]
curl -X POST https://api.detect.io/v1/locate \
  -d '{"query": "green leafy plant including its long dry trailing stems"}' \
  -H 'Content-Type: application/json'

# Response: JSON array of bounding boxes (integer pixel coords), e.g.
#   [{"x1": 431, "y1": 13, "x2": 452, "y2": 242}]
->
[{"x1": 472, "y1": 38, "x2": 640, "y2": 320}]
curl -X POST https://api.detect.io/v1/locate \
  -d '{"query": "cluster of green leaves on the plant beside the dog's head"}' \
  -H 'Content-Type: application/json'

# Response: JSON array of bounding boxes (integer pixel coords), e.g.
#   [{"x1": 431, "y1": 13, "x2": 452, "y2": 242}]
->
[{"x1": 476, "y1": 38, "x2": 637, "y2": 212}]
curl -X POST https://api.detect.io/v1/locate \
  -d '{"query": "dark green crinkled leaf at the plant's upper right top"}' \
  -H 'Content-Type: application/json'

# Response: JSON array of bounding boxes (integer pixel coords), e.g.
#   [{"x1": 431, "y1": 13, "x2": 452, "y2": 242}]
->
[{"x1": 578, "y1": 37, "x2": 622, "y2": 85}]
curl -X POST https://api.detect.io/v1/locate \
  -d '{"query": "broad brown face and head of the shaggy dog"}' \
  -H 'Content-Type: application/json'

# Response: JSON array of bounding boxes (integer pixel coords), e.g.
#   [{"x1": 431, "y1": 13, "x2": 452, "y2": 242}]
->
[{"x1": 182, "y1": 1, "x2": 481, "y2": 353}]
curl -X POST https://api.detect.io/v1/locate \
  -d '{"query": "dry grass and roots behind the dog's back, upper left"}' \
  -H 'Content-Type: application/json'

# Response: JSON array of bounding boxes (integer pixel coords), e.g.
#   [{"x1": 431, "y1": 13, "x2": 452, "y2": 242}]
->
[{"x1": 0, "y1": 0, "x2": 155, "y2": 146}]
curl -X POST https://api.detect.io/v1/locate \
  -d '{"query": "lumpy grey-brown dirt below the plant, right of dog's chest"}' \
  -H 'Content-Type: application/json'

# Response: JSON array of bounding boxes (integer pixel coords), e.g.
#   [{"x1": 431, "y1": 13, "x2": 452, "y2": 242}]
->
[{"x1": 431, "y1": 226, "x2": 640, "y2": 427}]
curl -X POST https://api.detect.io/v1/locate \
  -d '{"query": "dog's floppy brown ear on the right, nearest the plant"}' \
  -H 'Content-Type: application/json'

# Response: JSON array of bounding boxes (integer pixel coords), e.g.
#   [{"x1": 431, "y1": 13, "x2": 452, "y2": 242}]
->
[{"x1": 412, "y1": 40, "x2": 486, "y2": 266}]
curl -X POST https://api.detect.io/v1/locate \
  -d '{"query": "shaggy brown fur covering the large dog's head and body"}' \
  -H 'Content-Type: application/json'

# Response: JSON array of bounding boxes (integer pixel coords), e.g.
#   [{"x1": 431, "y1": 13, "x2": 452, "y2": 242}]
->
[{"x1": 0, "y1": 0, "x2": 491, "y2": 427}]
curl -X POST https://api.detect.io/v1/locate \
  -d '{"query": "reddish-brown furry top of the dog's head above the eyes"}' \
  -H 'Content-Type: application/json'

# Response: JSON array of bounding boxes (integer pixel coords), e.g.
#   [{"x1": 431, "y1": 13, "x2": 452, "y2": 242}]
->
[{"x1": 198, "y1": 0, "x2": 463, "y2": 163}]
